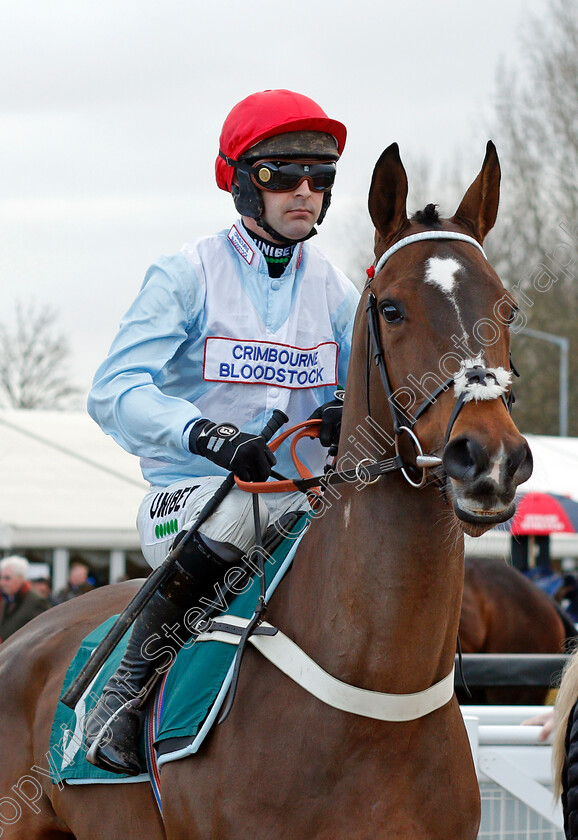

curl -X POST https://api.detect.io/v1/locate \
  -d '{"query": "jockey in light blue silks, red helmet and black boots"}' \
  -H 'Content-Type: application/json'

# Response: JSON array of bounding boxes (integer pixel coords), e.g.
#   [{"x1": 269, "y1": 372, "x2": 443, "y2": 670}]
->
[{"x1": 86, "y1": 90, "x2": 359, "y2": 775}]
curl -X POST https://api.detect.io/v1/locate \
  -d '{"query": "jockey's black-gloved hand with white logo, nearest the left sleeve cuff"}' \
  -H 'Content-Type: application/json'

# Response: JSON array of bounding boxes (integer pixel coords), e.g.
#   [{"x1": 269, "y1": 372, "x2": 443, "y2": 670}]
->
[{"x1": 189, "y1": 420, "x2": 277, "y2": 481}]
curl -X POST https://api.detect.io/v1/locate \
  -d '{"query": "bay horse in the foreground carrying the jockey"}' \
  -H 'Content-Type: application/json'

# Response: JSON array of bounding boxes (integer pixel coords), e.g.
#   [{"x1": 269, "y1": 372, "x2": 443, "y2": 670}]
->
[{"x1": 0, "y1": 143, "x2": 532, "y2": 840}]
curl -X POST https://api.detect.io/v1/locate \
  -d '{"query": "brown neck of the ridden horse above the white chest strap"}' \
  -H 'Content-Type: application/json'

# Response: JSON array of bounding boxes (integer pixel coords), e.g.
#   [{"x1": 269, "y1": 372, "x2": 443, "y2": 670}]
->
[{"x1": 274, "y1": 474, "x2": 463, "y2": 692}]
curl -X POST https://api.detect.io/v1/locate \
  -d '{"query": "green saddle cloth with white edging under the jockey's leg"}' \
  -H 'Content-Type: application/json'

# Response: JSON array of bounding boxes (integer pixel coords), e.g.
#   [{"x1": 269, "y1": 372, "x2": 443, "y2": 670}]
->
[{"x1": 49, "y1": 514, "x2": 312, "y2": 783}]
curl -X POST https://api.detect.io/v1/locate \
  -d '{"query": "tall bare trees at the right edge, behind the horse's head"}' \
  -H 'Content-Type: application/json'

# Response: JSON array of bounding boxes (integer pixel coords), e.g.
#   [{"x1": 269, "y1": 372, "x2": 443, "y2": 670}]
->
[{"x1": 488, "y1": 0, "x2": 578, "y2": 434}]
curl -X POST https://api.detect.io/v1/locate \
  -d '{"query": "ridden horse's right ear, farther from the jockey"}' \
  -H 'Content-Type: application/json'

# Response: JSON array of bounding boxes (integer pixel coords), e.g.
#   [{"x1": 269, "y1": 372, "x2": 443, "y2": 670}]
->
[{"x1": 452, "y1": 140, "x2": 500, "y2": 242}]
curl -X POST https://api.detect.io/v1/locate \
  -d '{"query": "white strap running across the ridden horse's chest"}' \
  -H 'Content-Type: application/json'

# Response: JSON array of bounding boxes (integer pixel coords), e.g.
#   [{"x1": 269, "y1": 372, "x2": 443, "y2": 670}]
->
[{"x1": 196, "y1": 615, "x2": 454, "y2": 721}]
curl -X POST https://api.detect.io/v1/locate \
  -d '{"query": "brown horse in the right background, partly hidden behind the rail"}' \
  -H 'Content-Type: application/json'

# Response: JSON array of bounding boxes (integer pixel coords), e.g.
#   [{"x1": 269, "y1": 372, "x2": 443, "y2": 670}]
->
[{"x1": 457, "y1": 556, "x2": 577, "y2": 706}]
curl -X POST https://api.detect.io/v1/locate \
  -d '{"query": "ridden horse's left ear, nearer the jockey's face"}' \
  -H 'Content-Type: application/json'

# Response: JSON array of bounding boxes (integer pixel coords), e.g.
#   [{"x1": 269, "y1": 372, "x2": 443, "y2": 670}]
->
[{"x1": 369, "y1": 143, "x2": 407, "y2": 240}]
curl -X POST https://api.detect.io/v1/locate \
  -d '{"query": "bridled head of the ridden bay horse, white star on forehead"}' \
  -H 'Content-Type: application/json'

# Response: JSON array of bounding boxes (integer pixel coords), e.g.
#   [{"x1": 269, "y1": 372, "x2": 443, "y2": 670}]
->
[{"x1": 356, "y1": 143, "x2": 532, "y2": 535}]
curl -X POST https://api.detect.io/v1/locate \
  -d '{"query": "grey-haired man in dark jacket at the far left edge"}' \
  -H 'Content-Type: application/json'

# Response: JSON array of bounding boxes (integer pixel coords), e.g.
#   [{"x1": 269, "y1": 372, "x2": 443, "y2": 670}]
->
[{"x1": 0, "y1": 554, "x2": 50, "y2": 642}]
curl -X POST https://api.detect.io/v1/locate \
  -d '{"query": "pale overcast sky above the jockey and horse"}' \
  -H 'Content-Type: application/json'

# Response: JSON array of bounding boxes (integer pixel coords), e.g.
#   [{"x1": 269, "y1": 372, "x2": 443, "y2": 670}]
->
[{"x1": 0, "y1": 0, "x2": 545, "y2": 400}]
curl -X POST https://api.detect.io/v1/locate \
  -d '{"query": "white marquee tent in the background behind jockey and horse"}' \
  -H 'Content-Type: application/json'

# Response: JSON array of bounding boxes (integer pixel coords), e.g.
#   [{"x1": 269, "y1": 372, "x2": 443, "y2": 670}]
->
[{"x1": 0, "y1": 410, "x2": 578, "y2": 586}]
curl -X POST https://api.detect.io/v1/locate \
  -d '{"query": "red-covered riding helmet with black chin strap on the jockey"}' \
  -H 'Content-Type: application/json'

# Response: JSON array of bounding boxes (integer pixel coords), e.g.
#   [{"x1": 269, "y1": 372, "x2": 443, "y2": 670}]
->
[{"x1": 215, "y1": 90, "x2": 347, "y2": 236}]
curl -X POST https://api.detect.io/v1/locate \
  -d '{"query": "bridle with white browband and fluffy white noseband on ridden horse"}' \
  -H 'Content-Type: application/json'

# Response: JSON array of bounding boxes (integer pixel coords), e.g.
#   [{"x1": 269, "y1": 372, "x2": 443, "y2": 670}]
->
[{"x1": 364, "y1": 230, "x2": 515, "y2": 487}]
